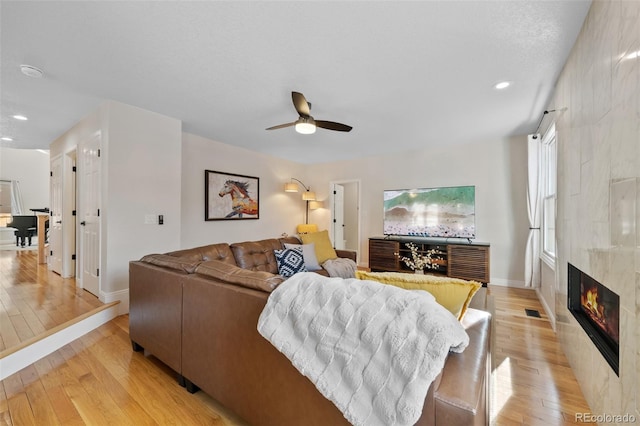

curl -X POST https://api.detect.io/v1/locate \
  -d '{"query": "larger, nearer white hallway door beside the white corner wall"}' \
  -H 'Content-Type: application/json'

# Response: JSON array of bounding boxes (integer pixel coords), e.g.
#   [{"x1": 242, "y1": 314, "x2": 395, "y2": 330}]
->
[{"x1": 78, "y1": 135, "x2": 101, "y2": 297}]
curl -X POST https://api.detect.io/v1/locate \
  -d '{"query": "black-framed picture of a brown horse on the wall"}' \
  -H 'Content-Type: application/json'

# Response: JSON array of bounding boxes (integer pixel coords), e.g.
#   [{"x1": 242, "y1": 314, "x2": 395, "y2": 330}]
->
[{"x1": 204, "y1": 170, "x2": 260, "y2": 220}]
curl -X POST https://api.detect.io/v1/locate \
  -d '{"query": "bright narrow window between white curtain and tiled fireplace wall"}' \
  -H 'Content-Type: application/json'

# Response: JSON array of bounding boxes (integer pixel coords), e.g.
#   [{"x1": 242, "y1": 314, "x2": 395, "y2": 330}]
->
[{"x1": 541, "y1": 124, "x2": 558, "y2": 266}]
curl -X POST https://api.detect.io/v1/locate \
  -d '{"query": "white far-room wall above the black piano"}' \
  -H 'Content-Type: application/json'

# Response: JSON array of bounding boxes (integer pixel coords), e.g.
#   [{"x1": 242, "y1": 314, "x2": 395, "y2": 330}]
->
[{"x1": 0, "y1": 148, "x2": 50, "y2": 210}]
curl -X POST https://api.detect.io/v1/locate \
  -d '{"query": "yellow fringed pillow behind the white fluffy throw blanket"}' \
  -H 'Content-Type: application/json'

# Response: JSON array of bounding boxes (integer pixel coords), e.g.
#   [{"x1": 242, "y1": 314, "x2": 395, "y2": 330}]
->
[{"x1": 356, "y1": 271, "x2": 482, "y2": 321}]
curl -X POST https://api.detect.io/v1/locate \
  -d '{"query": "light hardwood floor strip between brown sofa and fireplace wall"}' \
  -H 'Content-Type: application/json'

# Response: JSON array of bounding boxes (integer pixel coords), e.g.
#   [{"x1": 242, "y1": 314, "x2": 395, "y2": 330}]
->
[{"x1": 489, "y1": 286, "x2": 591, "y2": 426}]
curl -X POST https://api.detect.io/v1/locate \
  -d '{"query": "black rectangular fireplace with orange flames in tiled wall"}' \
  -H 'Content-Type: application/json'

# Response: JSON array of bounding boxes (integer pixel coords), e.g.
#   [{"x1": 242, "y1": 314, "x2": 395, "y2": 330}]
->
[{"x1": 568, "y1": 263, "x2": 620, "y2": 374}]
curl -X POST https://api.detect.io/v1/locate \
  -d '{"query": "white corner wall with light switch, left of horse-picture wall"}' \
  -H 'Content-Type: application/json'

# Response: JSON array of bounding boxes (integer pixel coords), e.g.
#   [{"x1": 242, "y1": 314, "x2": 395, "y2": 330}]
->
[{"x1": 51, "y1": 101, "x2": 182, "y2": 312}]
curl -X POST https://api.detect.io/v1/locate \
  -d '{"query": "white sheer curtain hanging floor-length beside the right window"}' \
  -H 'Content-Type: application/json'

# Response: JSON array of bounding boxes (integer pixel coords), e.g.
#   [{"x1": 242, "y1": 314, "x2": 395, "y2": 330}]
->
[{"x1": 524, "y1": 135, "x2": 541, "y2": 287}]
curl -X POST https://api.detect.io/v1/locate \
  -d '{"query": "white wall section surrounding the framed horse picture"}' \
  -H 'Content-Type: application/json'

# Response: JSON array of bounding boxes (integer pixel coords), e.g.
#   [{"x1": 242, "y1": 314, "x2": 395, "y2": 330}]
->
[{"x1": 180, "y1": 133, "x2": 306, "y2": 249}]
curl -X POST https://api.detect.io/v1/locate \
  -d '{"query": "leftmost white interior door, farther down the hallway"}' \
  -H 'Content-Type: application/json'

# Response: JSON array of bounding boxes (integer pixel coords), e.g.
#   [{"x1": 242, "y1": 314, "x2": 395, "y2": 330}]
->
[{"x1": 49, "y1": 156, "x2": 63, "y2": 275}]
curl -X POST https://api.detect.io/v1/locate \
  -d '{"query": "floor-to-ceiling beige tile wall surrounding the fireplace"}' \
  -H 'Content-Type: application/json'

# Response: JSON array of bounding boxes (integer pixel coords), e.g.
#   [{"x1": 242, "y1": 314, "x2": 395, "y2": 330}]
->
[{"x1": 549, "y1": 0, "x2": 640, "y2": 421}]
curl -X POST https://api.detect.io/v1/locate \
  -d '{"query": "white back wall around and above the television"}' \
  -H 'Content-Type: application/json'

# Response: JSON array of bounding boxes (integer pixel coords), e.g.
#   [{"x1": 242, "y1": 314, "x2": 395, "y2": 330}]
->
[{"x1": 307, "y1": 137, "x2": 529, "y2": 286}]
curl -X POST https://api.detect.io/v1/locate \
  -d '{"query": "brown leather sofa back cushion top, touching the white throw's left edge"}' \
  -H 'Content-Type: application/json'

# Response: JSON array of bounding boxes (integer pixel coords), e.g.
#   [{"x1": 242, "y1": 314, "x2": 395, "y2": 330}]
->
[{"x1": 195, "y1": 260, "x2": 284, "y2": 293}]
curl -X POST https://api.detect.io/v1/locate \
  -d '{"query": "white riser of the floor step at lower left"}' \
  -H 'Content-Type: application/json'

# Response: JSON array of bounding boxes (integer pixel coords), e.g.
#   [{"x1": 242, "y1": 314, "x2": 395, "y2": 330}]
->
[{"x1": 0, "y1": 305, "x2": 118, "y2": 380}]
